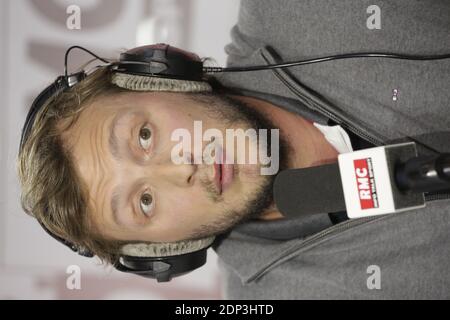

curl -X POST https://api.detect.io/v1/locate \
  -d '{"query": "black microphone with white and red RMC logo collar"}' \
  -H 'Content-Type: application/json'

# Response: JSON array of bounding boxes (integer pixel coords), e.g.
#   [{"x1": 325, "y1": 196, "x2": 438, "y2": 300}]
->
[{"x1": 273, "y1": 142, "x2": 450, "y2": 218}]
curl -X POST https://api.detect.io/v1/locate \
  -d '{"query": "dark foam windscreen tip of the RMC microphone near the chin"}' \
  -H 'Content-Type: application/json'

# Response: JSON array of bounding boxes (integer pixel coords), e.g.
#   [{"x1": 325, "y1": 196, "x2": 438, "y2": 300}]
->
[{"x1": 273, "y1": 163, "x2": 346, "y2": 218}]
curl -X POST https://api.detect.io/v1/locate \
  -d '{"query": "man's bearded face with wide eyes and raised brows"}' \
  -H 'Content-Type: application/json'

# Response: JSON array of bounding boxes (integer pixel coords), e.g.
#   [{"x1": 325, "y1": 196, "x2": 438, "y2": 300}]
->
[{"x1": 63, "y1": 92, "x2": 282, "y2": 242}]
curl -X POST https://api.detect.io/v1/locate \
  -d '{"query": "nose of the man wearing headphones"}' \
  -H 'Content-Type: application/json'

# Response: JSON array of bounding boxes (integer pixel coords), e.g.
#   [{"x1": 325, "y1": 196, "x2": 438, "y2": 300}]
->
[{"x1": 151, "y1": 155, "x2": 198, "y2": 187}]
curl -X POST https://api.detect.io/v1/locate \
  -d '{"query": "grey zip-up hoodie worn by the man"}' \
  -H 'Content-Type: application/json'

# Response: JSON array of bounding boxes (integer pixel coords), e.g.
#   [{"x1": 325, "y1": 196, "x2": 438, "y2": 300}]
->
[{"x1": 214, "y1": 0, "x2": 450, "y2": 299}]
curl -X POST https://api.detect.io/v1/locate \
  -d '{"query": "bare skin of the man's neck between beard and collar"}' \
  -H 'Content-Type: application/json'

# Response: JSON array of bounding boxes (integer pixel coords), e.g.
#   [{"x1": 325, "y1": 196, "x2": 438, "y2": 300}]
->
[{"x1": 232, "y1": 96, "x2": 338, "y2": 220}]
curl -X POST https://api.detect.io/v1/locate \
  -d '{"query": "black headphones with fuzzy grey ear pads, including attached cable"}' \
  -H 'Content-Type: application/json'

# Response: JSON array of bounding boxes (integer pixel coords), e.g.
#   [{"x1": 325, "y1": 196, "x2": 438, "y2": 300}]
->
[{"x1": 20, "y1": 43, "x2": 450, "y2": 282}]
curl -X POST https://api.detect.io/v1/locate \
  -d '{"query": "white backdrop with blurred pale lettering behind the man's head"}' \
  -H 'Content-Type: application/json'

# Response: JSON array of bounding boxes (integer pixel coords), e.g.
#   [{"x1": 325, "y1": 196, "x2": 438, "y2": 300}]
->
[{"x1": 0, "y1": 0, "x2": 243, "y2": 299}]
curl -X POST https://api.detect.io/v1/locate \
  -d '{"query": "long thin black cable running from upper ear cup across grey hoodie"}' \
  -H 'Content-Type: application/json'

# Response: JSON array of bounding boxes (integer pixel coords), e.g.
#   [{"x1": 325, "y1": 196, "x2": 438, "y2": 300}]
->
[{"x1": 203, "y1": 52, "x2": 450, "y2": 73}]
